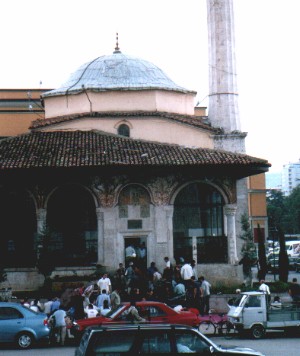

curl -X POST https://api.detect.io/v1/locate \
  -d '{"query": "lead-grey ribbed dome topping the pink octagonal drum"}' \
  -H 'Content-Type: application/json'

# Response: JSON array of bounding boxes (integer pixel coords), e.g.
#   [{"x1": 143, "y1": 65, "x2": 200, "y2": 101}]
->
[{"x1": 43, "y1": 51, "x2": 194, "y2": 97}]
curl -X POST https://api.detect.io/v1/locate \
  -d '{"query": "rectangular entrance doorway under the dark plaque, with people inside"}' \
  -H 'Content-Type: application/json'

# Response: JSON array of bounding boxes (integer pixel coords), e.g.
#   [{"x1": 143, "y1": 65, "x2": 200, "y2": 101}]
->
[{"x1": 125, "y1": 236, "x2": 147, "y2": 268}]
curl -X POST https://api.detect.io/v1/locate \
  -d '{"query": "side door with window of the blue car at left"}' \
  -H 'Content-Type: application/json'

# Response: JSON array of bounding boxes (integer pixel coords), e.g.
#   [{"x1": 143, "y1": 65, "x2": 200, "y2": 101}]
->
[{"x1": 0, "y1": 306, "x2": 25, "y2": 342}]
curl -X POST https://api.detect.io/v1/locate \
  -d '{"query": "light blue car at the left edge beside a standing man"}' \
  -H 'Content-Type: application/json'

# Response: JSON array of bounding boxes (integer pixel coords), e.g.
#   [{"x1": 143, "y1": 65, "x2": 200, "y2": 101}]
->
[{"x1": 0, "y1": 302, "x2": 50, "y2": 349}]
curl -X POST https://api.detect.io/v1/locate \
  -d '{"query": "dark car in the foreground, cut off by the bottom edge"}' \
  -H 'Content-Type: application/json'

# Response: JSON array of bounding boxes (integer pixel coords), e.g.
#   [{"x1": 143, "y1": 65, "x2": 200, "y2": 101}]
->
[{"x1": 75, "y1": 324, "x2": 263, "y2": 356}]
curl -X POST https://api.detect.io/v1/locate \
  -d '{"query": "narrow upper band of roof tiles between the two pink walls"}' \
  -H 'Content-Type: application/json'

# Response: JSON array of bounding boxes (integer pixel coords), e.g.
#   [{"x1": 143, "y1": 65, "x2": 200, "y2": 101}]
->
[{"x1": 30, "y1": 111, "x2": 218, "y2": 132}]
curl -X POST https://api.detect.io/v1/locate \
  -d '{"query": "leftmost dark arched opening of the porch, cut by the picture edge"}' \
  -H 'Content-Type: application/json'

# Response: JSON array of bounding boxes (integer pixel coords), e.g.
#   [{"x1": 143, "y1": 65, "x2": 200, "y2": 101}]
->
[{"x1": 0, "y1": 188, "x2": 37, "y2": 267}]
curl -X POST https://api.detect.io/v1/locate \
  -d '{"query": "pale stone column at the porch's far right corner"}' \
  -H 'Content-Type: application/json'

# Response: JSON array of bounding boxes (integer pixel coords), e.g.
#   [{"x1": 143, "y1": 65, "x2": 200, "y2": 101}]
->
[{"x1": 224, "y1": 204, "x2": 238, "y2": 265}]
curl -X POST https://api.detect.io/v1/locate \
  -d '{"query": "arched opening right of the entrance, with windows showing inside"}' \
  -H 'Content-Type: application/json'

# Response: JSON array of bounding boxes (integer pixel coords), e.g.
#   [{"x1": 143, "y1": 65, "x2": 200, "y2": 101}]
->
[{"x1": 173, "y1": 183, "x2": 227, "y2": 263}]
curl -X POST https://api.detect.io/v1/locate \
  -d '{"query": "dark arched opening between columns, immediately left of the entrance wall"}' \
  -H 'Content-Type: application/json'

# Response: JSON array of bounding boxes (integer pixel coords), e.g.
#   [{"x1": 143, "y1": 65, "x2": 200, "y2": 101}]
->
[{"x1": 47, "y1": 185, "x2": 97, "y2": 266}]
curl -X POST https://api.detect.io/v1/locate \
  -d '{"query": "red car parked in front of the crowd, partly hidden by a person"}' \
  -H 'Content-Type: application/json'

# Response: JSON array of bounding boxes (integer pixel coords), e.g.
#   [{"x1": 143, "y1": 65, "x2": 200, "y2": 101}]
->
[{"x1": 75, "y1": 301, "x2": 201, "y2": 333}]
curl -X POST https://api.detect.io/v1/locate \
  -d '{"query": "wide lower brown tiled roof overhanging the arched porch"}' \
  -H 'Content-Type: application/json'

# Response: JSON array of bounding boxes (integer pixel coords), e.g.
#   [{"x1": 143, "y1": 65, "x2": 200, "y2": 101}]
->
[{"x1": 0, "y1": 131, "x2": 269, "y2": 170}]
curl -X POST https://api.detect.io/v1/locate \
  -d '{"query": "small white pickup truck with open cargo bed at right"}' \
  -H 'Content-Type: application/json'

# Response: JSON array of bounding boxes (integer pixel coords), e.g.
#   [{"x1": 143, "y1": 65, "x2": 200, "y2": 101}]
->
[{"x1": 227, "y1": 291, "x2": 300, "y2": 339}]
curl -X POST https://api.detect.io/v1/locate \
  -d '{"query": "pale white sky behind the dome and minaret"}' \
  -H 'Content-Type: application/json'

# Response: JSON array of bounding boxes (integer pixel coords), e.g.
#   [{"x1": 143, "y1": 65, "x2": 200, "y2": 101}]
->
[{"x1": 0, "y1": 0, "x2": 300, "y2": 173}]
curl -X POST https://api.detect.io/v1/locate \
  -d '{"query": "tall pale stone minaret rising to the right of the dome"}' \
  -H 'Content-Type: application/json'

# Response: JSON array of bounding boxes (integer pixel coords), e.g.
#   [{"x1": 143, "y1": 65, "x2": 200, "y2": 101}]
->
[{"x1": 207, "y1": 0, "x2": 246, "y2": 153}]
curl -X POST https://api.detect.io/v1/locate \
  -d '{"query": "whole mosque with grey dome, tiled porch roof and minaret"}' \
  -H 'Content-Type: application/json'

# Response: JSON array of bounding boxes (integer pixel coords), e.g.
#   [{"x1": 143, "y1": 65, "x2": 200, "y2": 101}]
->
[{"x1": 0, "y1": 0, "x2": 270, "y2": 290}]
